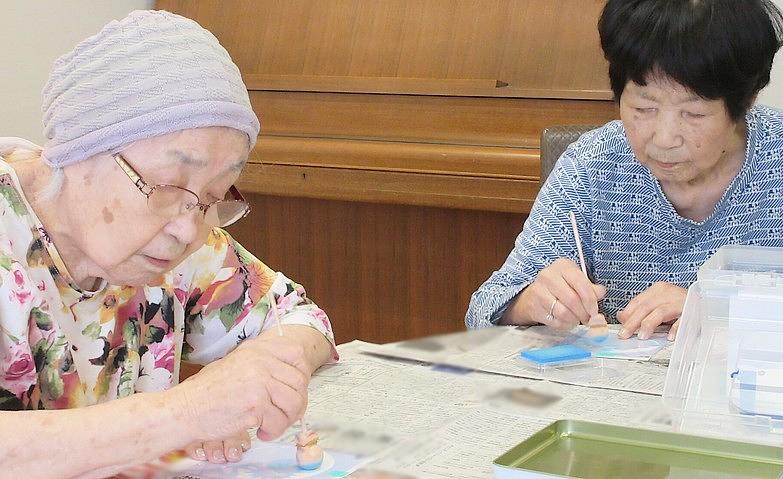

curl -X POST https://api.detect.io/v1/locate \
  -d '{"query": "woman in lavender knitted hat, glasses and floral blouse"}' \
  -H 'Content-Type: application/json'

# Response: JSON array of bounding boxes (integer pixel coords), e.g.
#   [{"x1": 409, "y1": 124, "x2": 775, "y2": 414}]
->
[{"x1": 0, "y1": 11, "x2": 336, "y2": 478}]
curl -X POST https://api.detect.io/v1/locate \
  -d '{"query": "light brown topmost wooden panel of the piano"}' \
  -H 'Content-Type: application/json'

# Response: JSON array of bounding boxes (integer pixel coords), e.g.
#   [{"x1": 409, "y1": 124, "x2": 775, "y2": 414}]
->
[{"x1": 158, "y1": 0, "x2": 609, "y2": 96}]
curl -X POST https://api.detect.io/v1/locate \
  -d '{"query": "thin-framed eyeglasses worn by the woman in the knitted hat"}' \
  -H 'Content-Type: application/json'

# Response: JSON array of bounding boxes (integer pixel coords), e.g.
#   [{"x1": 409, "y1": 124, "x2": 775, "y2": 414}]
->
[{"x1": 114, "y1": 153, "x2": 250, "y2": 228}]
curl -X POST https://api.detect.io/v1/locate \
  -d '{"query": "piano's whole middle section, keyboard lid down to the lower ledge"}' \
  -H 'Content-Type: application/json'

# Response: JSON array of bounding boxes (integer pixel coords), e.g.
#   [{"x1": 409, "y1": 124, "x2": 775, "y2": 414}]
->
[{"x1": 241, "y1": 92, "x2": 616, "y2": 212}]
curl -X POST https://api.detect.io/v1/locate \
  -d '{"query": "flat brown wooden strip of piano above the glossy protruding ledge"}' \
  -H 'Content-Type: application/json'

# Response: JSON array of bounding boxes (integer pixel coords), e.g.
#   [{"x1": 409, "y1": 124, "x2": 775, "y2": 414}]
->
[{"x1": 250, "y1": 91, "x2": 617, "y2": 148}]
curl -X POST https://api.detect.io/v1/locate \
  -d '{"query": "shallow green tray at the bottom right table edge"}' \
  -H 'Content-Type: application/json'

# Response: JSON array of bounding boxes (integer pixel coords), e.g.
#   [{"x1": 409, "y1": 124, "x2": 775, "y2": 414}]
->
[{"x1": 495, "y1": 420, "x2": 783, "y2": 479}]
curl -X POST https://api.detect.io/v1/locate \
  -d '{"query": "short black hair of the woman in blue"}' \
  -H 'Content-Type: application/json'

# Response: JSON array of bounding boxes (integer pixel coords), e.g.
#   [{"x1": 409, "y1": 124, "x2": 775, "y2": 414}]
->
[{"x1": 598, "y1": 0, "x2": 783, "y2": 121}]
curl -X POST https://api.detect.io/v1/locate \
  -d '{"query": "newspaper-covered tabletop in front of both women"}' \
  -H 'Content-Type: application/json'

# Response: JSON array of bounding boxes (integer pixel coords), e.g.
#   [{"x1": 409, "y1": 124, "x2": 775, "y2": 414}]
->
[{"x1": 125, "y1": 327, "x2": 669, "y2": 479}]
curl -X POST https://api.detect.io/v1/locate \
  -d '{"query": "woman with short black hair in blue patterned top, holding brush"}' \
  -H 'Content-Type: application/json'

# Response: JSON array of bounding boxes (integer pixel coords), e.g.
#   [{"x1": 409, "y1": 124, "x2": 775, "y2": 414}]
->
[{"x1": 465, "y1": 0, "x2": 783, "y2": 339}]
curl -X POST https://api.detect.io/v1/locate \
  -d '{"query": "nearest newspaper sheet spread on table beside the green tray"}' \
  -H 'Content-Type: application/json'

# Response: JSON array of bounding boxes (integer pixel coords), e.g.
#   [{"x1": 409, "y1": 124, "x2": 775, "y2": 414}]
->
[{"x1": 300, "y1": 343, "x2": 665, "y2": 479}]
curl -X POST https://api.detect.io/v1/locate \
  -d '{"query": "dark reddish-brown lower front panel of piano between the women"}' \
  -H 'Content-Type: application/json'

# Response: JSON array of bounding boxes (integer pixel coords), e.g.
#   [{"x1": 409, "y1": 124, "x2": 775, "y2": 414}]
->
[{"x1": 224, "y1": 195, "x2": 525, "y2": 342}]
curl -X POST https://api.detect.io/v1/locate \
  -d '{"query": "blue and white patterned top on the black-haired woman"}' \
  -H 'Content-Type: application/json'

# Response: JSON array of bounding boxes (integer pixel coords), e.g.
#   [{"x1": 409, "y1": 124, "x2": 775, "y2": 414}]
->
[{"x1": 465, "y1": 106, "x2": 783, "y2": 328}]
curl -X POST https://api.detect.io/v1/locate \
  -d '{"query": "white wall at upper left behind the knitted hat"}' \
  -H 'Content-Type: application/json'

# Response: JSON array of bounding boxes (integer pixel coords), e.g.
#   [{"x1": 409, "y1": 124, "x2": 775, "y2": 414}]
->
[{"x1": 0, "y1": 0, "x2": 155, "y2": 143}]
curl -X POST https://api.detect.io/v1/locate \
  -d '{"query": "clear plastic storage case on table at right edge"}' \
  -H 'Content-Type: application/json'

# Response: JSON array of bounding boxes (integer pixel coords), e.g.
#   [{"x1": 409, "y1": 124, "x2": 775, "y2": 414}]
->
[{"x1": 663, "y1": 246, "x2": 783, "y2": 445}]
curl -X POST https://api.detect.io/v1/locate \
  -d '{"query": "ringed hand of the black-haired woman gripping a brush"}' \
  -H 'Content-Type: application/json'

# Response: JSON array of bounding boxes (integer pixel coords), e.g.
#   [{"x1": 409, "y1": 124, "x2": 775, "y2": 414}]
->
[{"x1": 502, "y1": 258, "x2": 606, "y2": 330}]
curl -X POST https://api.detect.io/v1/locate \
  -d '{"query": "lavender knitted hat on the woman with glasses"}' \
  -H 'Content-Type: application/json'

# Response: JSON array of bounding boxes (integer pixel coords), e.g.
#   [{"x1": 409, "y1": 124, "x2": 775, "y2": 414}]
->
[{"x1": 42, "y1": 10, "x2": 260, "y2": 167}]
